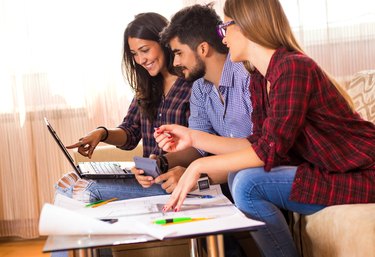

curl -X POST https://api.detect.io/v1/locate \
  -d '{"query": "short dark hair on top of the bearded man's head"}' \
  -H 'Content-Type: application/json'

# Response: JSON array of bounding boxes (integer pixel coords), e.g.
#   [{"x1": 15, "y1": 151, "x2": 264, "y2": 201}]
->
[{"x1": 161, "y1": 3, "x2": 228, "y2": 54}]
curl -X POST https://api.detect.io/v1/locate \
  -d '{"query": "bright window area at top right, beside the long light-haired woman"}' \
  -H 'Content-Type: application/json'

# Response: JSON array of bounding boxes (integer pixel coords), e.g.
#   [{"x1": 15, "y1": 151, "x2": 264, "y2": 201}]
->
[{"x1": 280, "y1": 0, "x2": 375, "y2": 44}]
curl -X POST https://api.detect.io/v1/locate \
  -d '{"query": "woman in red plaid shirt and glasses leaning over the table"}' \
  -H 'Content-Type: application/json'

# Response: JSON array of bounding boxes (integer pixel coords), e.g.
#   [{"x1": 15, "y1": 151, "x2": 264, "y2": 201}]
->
[{"x1": 154, "y1": 0, "x2": 375, "y2": 257}]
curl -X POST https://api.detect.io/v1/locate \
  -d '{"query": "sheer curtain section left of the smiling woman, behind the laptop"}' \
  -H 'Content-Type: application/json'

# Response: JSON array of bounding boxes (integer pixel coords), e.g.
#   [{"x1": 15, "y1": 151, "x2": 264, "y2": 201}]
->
[{"x1": 0, "y1": 0, "x2": 182, "y2": 238}]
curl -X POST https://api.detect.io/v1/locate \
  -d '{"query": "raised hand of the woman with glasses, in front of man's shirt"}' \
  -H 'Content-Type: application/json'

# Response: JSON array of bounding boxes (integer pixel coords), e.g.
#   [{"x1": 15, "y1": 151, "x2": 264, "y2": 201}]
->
[{"x1": 154, "y1": 125, "x2": 193, "y2": 152}]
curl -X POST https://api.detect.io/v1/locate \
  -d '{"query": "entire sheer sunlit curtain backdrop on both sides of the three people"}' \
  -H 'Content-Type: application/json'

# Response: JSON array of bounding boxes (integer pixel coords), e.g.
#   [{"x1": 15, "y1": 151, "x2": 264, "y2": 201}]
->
[{"x1": 0, "y1": 0, "x2": 375, "y2": 238}]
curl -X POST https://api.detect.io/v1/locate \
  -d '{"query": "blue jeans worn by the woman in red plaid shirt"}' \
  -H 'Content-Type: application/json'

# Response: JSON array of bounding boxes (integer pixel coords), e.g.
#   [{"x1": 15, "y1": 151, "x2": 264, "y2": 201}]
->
[{"x1": 228, "y1": 166, "x2": 325, "y2": 257}]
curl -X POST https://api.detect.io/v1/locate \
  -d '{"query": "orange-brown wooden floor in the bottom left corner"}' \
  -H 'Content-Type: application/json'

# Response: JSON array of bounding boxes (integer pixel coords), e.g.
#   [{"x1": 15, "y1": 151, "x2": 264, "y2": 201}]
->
[{"x1": 0, "y1": 239, "x2": 50, "y2": 257}]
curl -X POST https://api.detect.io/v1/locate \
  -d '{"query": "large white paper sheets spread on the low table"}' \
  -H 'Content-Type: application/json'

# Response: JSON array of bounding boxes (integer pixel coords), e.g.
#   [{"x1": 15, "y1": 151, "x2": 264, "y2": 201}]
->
[{"x1": 39, "y1": 186, "x2": 263, "y2": 239}]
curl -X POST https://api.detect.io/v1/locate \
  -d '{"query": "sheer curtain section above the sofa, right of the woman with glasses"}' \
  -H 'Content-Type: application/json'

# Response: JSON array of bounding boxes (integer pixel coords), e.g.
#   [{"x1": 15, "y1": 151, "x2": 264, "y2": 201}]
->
[{"x1": 281, "y1": 0, "x2": 375, "y2": 83}]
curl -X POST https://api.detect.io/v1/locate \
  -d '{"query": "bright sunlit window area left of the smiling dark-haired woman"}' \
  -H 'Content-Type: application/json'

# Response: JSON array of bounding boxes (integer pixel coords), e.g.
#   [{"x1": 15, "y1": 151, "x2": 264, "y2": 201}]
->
[{"x1": 0, "y1": 0, "x2": 182, "y2": 112}]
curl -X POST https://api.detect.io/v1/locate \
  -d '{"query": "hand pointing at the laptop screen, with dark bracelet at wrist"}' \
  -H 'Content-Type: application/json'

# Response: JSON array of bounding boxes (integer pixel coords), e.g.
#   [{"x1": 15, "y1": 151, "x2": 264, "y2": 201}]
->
[{"x1": 66, "y1": 129, "x2": 105, "y2": 158}]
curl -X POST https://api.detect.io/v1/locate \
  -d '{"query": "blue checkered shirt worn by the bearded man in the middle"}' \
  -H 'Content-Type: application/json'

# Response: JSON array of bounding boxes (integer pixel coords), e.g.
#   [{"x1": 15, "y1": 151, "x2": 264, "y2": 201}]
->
[{"x1": 189, "y1": 55, "x2": 252, "y2": 154}]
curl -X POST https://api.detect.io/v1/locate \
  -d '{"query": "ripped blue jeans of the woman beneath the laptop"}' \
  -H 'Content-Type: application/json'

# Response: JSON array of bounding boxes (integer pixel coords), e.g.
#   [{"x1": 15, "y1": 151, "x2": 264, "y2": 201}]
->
[{"x1": 51, "y1": 173, "x2": 167, "y2": 257}]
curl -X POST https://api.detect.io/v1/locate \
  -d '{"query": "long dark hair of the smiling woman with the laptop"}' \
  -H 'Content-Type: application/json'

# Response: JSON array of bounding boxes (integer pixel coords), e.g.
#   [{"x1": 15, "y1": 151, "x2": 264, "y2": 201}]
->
[{"x1": 122, "y1": 12, "x2": 176, "y2": 122}]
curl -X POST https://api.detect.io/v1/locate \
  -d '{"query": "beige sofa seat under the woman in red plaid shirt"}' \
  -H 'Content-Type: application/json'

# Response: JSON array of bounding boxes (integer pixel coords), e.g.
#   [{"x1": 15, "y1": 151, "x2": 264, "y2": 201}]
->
[{"x1": 300, "y1": 204, "x2": 375, "y2": 257}]
